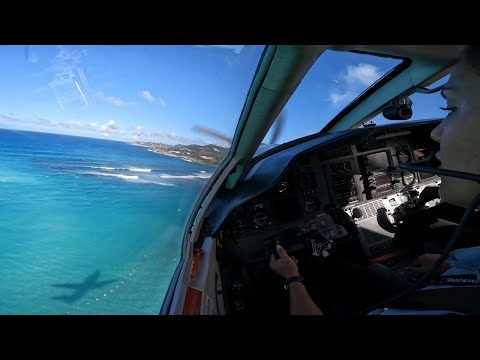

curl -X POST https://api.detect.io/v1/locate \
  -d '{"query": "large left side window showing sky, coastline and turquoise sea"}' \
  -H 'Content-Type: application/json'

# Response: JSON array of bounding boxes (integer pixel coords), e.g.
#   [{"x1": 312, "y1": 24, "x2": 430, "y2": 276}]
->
[{"x1": 0, "y1": 45, "x2": 264, "y2": 314}]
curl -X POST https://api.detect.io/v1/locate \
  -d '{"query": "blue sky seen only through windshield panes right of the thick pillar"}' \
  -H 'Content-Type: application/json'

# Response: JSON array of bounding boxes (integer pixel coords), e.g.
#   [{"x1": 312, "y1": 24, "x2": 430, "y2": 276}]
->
[{"x1": 264, "y1": 51, "x2": 448, "y2": 143}]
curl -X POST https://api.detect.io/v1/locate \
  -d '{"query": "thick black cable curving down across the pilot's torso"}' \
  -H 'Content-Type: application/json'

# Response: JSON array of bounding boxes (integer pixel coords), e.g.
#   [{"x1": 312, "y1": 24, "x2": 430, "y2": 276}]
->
[{"x1": 360, "y1": 193, "x2": 480, "y2": 314}]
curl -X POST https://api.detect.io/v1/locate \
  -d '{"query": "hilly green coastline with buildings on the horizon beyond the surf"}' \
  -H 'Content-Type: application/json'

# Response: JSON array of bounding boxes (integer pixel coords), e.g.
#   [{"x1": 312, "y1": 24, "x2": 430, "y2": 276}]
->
[{"x1": 130, "y1": 141, "x2": 230, "y2": 166}]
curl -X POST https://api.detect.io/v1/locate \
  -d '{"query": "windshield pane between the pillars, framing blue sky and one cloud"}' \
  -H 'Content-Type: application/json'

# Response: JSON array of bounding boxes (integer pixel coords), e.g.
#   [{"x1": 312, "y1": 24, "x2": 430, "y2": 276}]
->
[{"x1": 263, "y1": 50, "x2": 402, "y2": 145}]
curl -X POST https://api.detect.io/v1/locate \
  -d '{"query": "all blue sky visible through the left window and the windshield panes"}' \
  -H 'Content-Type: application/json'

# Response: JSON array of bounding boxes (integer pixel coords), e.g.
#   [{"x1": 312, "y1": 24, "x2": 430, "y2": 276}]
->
[{"x1": 0, "y1": 45, "x2": 445, "y2": 144}]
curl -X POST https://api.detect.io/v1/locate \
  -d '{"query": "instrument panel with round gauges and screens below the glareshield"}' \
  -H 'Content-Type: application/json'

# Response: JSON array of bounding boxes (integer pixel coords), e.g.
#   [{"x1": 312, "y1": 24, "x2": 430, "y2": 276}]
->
[{"x1": 216, "y1": 122, "x2": 440, "y2": 264}]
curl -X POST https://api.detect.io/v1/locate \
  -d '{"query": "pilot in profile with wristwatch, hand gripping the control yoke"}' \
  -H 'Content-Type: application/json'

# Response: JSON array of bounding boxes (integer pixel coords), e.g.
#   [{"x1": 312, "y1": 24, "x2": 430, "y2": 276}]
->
[{"x1": 269, "y1": 46, "x2": 480, "y2": 315}]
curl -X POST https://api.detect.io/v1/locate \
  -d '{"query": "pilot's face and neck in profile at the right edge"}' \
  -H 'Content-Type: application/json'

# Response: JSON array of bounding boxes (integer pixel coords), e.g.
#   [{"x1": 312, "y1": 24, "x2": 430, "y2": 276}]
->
[{"x1": 431, "y1": 46, "x2": 480, "y2": 207}]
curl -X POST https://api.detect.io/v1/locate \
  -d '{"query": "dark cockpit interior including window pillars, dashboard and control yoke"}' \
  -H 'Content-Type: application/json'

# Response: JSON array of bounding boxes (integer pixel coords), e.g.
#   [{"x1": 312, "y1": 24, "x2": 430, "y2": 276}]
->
[{"x1": 162, "y1": 45, "x2": 478, "y2": 315}]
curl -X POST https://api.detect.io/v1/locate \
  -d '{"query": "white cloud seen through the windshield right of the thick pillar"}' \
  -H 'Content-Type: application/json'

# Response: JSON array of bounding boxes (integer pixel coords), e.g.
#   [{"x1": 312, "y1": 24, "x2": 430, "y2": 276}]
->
[{"x1": 328, "y1": 63, "x2": 382, "y2": 106}]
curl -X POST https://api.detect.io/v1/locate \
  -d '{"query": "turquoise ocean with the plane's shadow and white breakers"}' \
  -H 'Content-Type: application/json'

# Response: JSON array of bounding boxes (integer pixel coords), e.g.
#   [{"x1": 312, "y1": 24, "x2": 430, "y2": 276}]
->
[{"x1": 0, "y1": 129, "x2": 214, "y2": 315}]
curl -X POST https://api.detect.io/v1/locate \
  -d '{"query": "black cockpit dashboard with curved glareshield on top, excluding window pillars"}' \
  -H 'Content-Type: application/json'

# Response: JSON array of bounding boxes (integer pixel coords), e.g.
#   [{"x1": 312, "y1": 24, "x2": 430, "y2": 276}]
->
[{"x1": 206, "y1": 121, "x2": 458, "y2": 314}]
